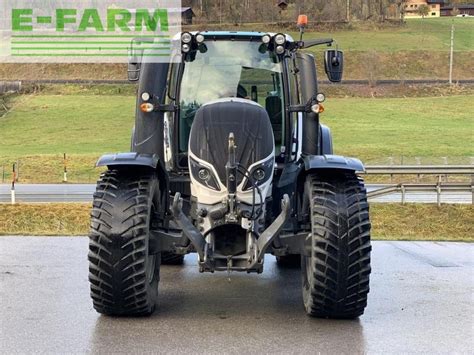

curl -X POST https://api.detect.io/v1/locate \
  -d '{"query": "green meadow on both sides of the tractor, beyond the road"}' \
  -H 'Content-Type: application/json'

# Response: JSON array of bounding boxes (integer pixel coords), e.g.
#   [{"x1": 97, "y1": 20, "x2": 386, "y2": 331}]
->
[{"x1": 0, "y1": 90, "x2": 474, "y2": 183}]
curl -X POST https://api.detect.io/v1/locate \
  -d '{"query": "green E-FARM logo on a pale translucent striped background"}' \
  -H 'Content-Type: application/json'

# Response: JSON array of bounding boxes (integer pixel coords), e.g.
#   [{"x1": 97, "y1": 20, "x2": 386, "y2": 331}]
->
[{"x1": 0, "y1": 0, "x2": 181, "y2": 63}]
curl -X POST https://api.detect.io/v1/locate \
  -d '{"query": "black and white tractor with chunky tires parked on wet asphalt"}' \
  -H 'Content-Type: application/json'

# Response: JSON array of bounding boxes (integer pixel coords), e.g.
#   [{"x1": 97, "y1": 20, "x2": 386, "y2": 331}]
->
[{"x1": 89, "y1": 25, "x2": 371, "y2": 318}]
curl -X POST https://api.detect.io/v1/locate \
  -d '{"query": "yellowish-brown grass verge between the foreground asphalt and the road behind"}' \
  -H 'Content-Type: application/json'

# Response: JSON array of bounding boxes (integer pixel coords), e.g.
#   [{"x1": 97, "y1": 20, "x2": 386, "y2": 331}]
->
[{"x1": 0, "y1": 204, "x2": 474, "y2": 242}]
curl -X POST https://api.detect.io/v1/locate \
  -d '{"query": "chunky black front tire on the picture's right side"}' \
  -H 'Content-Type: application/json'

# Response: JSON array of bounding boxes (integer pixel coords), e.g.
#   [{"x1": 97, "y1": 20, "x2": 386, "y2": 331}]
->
[{"x1": 301, "y1": 173, "x2": 371, "y2": 318}]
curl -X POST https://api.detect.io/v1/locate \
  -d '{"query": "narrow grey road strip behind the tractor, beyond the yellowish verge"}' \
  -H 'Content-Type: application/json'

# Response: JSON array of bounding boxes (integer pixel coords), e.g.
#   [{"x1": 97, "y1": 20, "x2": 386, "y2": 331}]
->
[{"x1": 0, "y1": 184, "x2": 472, "y2": 204}]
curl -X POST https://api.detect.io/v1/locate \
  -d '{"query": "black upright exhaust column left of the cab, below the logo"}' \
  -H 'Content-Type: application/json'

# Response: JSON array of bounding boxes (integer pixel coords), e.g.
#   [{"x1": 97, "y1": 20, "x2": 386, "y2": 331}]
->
[{"x1": 132, "y1": 63, "x2": 170, "y2": 161}]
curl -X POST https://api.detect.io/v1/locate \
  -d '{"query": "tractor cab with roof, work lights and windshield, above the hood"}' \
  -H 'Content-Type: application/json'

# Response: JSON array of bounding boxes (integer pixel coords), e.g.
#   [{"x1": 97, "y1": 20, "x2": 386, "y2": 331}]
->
[{"x1": 129, "y1": 31, "x2": 343, "y2": 172}]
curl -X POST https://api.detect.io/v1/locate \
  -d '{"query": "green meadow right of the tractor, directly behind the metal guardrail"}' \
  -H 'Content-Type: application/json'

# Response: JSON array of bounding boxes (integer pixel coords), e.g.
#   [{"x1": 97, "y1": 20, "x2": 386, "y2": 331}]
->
[{"x1": 322, "y1": 95, "x2": 474, "y2": 162}]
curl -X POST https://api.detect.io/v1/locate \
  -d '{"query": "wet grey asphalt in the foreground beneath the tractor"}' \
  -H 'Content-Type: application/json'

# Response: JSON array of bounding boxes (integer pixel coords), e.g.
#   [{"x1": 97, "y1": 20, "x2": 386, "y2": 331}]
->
[{"x1": 0, "y1": 237, "x2": 474, "y2": 354}]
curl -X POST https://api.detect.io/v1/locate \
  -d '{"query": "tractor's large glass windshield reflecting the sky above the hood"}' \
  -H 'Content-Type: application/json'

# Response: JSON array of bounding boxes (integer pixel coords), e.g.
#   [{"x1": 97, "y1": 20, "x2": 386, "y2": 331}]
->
[{"x1": 179, "y1": 41, "x2": 284, "y2": 152}]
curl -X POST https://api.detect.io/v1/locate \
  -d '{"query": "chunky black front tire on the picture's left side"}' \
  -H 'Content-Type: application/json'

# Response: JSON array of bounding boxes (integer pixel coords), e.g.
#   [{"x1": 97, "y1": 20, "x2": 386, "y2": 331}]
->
[{"x1": 89, "y1": 170, "x2": 161, "y2": 316}]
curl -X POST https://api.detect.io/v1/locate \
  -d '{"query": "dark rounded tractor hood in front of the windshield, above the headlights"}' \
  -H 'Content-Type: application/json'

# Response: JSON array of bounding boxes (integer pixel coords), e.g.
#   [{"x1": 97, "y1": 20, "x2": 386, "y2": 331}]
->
[{"x1": 189, "y1": 98, "x2": 274, "y2": 189}]
